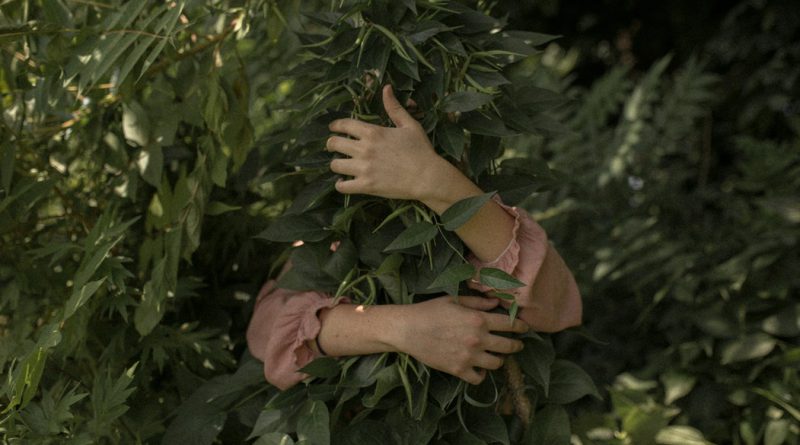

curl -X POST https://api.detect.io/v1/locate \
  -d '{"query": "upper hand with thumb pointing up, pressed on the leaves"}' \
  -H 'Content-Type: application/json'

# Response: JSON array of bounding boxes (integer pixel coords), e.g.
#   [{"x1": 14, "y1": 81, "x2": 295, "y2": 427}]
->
[{"x1": 326, "y1": 85, "x2": 452, "y2": 201}]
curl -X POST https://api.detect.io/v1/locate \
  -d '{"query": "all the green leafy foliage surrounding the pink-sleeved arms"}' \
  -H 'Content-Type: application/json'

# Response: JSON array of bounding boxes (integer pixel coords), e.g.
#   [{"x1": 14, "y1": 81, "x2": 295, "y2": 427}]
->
[{"x1": 0, "y1": 0, "x2": 800, "y2": 445}]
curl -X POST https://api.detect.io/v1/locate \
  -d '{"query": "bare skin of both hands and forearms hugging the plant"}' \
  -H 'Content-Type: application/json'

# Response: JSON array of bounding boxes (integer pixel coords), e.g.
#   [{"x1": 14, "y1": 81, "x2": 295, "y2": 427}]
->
[{"x1": 316, "y1": 85, "x2": 528, "y2": 384}]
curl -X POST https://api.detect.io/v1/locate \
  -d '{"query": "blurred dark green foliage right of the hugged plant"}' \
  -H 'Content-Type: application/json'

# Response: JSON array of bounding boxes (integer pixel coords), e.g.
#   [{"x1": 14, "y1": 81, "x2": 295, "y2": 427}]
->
[{"x1": 506, "y1": 4, "x2": 800, "y2": 444}]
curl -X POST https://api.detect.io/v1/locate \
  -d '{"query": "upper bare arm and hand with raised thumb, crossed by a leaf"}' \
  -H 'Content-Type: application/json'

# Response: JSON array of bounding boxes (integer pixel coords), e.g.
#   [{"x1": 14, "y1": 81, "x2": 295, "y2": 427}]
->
[{"x1": 327, "y1": 85, "x2": 514, "y2": 262}]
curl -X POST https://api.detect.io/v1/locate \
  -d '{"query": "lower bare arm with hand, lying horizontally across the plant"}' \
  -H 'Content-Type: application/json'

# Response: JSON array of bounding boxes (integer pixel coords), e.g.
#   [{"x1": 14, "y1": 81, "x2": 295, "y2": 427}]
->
[{"x1": 318, "y1": 297, "x2": 528, "y2": 384}]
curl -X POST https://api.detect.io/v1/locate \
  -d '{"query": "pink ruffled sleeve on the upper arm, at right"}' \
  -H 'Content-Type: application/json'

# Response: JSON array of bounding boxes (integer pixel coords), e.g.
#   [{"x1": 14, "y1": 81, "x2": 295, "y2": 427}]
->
[{"x1": 469, "y1": 198, "x2": 583, "y2": 332}]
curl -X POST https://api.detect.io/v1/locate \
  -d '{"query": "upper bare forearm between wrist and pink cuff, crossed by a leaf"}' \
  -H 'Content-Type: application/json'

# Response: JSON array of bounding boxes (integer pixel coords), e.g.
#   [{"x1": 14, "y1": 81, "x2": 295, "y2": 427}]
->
[{"x1": 421, "y1": 159, "x2": 514, "y2": 262}]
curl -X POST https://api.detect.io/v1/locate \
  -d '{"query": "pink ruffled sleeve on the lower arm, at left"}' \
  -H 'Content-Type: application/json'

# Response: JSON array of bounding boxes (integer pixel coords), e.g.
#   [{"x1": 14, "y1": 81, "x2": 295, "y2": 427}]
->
[{"x1": 247, "y1": 280, "x2": 348, "y2": 390}]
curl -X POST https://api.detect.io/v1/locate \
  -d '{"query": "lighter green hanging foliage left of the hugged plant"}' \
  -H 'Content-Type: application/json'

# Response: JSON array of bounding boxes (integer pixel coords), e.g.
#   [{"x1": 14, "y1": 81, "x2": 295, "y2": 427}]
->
[{"x1": 0, "y1": 0, "x2": 292, "y2": 443}]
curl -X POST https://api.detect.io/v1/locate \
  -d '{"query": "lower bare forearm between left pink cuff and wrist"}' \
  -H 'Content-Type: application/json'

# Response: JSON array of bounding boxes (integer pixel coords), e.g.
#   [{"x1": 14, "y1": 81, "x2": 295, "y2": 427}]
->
[{"x1": 310, "y1": 304, "x2": 404, "y2": 357}]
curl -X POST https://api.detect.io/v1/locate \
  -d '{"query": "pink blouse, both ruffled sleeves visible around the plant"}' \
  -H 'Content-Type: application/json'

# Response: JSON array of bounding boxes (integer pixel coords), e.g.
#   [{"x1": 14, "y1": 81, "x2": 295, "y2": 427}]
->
[{"x1": 247, "y1": 201, "x2": 582, "y2": 389}]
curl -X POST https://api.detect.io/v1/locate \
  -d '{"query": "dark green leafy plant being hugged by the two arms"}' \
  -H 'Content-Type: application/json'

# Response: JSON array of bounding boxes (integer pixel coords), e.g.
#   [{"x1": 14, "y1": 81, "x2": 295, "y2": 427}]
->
[{"x1": 253, "y1": 1, "x2": 596, "y2": 444}]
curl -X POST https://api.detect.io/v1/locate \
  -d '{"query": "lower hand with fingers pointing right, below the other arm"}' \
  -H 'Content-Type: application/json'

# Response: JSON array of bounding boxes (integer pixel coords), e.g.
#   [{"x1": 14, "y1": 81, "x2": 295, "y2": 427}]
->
[{"x1": 394, "y1": 297, "x2": 528, "y2": 385}]
